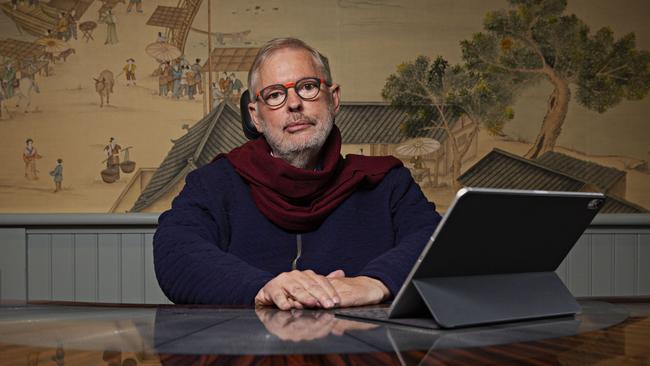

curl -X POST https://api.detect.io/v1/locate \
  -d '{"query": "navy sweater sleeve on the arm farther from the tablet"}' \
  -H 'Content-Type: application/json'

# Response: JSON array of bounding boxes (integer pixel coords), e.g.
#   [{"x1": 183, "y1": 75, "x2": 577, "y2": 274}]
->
[{"x1": 154, "y1": 167, "x2": 273, "y2": 305}]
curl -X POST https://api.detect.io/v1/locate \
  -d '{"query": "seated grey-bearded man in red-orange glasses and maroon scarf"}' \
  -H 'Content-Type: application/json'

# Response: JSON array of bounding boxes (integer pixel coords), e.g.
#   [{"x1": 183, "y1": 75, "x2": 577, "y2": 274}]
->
[{"x1": 154, "y1": 38, "x2": 440, "y2": 310}]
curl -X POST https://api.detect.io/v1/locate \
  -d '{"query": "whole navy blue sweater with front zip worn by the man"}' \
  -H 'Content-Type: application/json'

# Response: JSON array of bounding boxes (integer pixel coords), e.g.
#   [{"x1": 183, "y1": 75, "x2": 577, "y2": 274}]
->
[{"x1": 154, "y1": 159, "x2": 440, "y2": 305}]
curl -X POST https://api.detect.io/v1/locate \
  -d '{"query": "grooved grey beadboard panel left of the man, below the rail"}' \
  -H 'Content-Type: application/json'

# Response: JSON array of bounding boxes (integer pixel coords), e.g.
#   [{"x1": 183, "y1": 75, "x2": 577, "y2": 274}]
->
[{"x1": 27, "y1": 229, "x2": 169, "y2": 304}]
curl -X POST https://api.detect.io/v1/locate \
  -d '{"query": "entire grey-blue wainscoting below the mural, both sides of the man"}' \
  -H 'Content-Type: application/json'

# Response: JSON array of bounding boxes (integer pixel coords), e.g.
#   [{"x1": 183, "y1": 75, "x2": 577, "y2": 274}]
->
[{"x1": 0, "y1": 214, "x2": 650, "y2": 304}]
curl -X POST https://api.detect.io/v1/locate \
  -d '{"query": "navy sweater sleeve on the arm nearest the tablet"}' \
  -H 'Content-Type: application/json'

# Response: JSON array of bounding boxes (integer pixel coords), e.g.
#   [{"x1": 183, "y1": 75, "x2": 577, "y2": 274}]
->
[{"x1": 358, "y1": 168, "x2": 441, "y2": 296}]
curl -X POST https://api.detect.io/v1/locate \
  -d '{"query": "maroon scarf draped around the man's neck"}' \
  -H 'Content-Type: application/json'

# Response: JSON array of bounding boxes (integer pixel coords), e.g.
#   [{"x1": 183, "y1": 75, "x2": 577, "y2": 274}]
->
[{"x1": 215, "y1": 126, "x2": 402, "y2": 232}]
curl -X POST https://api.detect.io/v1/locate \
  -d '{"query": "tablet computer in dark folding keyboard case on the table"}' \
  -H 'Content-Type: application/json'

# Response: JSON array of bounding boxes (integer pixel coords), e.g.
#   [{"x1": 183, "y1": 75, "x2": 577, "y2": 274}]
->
[{"x1": 337, "y1": 188, "x2": 605, "y2": 328}]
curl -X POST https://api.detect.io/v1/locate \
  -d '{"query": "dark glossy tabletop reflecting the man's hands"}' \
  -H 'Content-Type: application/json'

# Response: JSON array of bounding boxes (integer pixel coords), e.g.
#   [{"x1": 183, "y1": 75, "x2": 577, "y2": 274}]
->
[{"x1": 0, "y1": 301, "x2": 650, "y2": 366}]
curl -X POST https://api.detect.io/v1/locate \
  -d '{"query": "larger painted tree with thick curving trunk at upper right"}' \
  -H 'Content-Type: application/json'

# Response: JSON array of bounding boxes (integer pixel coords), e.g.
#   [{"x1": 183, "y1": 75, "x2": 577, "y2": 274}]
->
[{"x1": 461, "y1": 0, "x2": 650, "y2": 158}]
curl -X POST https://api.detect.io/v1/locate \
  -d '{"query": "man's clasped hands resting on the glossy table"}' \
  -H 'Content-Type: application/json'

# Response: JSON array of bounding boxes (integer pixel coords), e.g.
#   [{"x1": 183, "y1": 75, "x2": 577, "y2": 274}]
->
[{"x1": 255, "y1": 270, "x2": 390, "y2": 310}]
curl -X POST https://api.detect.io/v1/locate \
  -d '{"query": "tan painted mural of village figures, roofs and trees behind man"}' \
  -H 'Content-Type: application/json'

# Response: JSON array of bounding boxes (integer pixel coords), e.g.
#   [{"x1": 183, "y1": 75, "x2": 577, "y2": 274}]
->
[{"x1": 0, "y1": 0, "x2": 650, "y2": 213}]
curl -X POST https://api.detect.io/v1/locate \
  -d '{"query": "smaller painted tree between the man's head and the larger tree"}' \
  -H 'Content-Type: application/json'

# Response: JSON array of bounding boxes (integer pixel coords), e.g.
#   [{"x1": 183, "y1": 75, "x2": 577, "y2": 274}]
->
[{"x1": 382, "y1": 56, "x2": 517, "y2": 188}]
